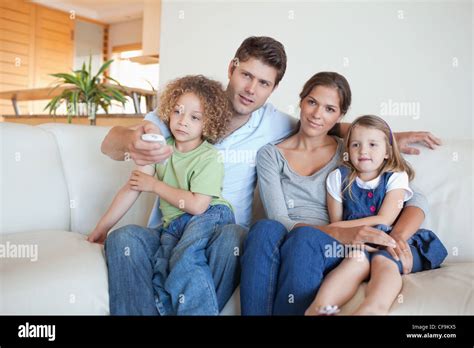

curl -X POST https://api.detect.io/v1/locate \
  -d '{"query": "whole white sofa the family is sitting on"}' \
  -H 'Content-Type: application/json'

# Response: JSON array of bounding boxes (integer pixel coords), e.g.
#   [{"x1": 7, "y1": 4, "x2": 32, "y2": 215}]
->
[{"x1": 0, "y1": 123, "x2": 474, "y2": 315}]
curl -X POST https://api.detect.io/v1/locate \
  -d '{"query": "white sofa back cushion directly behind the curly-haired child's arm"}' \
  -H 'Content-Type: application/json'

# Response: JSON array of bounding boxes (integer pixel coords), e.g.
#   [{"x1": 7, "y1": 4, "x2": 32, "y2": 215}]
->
[{"x1": 38, "y1": 123, "x2": 156, "y2": 234}]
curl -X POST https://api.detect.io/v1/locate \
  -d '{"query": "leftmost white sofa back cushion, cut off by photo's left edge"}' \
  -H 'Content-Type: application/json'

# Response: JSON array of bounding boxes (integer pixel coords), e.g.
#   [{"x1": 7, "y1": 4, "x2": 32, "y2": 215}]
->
[{"x1": 0, "y1": 123, "x2": 70, "y2": 234}]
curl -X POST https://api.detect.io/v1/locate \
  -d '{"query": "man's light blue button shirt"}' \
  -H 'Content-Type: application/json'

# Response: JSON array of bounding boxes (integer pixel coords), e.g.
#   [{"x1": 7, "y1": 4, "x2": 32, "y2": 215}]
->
[{"x1": 145, "y1": 103, "x2": 298, "y2": 228}]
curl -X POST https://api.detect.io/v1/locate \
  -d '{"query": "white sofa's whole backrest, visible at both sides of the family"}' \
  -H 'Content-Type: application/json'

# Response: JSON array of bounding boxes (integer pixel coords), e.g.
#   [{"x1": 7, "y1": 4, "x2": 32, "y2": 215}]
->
[{"x1": 0, "y1": 123, "x2": 474, "y2": 262}]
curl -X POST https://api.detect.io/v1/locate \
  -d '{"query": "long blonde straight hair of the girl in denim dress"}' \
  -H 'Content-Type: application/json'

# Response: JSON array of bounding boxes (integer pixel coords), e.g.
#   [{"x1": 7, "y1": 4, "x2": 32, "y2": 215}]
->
[{"x1": 343, "y1": 115, "x2": 415, "y2": 198}]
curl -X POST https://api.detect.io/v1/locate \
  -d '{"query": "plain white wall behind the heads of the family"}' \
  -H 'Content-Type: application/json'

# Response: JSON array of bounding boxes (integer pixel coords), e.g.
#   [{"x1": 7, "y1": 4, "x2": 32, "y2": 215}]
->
[{"x1": 160, "y1": 0, "x2": 473, "y2": 138}]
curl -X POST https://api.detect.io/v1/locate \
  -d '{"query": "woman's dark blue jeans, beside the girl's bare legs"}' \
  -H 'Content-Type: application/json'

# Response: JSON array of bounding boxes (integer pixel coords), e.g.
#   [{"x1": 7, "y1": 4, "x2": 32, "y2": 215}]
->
[{"x1": 240, "y1": 220, "x2": 421, "y2": 315}]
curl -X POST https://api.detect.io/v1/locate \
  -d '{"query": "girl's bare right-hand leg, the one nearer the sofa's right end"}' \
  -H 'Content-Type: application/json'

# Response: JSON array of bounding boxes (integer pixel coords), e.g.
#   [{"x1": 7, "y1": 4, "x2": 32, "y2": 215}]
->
[{"x1": 354, "y1": 255, "x2": 402, "y2": 315}]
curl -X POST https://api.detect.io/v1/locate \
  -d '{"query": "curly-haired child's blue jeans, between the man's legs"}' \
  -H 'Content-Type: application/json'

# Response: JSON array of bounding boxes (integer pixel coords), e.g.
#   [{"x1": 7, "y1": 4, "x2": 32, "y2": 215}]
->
[{"x1": 153, "y1": 205, "x2": 235, "y2": 315}]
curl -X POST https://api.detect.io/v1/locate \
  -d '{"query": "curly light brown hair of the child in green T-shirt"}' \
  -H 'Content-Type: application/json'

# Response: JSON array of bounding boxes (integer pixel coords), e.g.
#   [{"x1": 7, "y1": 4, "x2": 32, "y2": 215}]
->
[{"x1": 158, "y1": 75, "x2": 233, "y2": 144}]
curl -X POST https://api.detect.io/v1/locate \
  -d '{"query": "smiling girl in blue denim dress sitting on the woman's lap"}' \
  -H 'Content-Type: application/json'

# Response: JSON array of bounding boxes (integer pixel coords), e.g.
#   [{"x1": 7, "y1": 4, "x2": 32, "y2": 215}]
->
[{"x1": 306, "y1": 116, "x2": 447, "y2": 315}]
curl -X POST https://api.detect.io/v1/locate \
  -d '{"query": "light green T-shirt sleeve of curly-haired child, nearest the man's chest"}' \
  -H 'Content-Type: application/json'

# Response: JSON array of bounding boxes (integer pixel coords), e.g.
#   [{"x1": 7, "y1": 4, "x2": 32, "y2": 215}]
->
[{"x1": 189, "y1": 156, "x2": 224, "y2": 197}]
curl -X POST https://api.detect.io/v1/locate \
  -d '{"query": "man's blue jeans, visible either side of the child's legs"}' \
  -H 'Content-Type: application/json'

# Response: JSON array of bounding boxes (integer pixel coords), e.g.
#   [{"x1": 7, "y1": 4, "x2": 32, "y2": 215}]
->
[{"x1": 105, "y1": 205, "x2": 247, "y2": 315}]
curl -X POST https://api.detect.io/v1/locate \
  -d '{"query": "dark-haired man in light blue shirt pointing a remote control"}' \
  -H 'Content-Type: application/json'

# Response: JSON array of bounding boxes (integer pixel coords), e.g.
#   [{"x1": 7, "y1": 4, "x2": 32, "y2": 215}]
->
[{"x1": 102, "y1": 37, "x2": 439, "y2": 315}]
